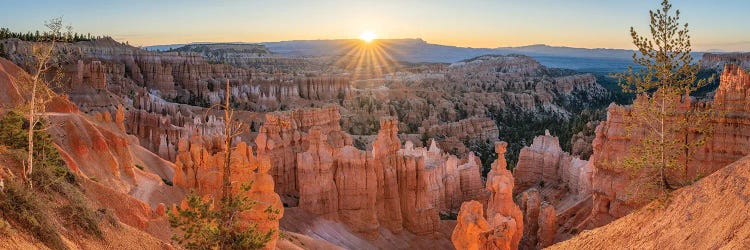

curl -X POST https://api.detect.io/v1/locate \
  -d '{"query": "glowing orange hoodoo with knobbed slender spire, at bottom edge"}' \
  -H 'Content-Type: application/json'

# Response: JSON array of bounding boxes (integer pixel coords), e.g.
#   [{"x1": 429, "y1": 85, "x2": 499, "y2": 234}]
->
[{"x1": 451, "y1": 142, "x2": 524, "y2": 250}]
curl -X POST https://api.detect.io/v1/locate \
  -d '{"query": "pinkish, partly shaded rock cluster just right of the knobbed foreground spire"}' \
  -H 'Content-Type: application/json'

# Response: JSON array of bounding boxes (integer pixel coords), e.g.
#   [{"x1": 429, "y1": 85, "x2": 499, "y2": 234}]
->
[{"x1": 513, "y1": 132, "x2": 592, "y2": 249}]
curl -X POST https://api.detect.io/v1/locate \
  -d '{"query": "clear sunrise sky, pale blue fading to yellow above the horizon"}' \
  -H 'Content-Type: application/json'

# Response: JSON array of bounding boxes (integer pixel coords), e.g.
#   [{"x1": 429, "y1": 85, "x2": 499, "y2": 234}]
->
[{"x1": 0, "y1": 0, "x2": 750, "y2": 51}]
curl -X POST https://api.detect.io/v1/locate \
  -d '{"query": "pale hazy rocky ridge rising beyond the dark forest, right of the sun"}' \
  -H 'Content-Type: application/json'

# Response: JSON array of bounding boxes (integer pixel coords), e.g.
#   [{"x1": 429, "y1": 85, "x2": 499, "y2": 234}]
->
[{"x1": 446, "y1": 55, "x2": 606, "y2": 116}]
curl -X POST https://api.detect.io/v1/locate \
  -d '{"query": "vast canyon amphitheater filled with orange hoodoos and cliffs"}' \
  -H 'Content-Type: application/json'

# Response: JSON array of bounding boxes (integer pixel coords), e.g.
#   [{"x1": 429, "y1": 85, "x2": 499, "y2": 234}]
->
[{"x1": 0, "y1": 32, "x2": 750, "y2": 249}]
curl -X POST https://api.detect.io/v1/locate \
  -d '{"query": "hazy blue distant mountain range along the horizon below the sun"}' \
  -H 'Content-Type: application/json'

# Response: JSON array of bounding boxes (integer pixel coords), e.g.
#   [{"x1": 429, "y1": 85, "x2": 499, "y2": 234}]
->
[{"x1": 145, "y1": 38, "x2": 716, "y2": 73}]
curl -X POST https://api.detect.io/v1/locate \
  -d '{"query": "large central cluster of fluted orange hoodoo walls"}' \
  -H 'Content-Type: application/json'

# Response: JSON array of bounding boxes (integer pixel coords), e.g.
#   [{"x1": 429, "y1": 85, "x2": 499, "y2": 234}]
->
[{"x1": 256, "y1": 107, "x2": 486, "y2": 240}]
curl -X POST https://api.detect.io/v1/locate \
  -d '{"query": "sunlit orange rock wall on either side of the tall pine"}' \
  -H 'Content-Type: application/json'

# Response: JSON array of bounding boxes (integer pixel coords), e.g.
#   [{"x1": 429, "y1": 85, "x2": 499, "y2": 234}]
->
[{"x1": 590, "y1": 64, "x2": 750, "y2": 225}]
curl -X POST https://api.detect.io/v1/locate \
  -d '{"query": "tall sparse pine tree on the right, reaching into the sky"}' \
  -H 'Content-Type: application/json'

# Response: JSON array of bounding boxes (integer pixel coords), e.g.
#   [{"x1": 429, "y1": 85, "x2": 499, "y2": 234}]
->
[{"x1": 617, "y1": 0, "x2": 716, "y2": 201}]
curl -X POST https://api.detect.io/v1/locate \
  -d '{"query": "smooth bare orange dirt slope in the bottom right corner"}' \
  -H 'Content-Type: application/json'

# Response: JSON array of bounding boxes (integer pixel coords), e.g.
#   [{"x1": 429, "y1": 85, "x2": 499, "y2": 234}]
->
[{"x1": 550, "y1": 156, "x2": 750, "y2": 249}]
